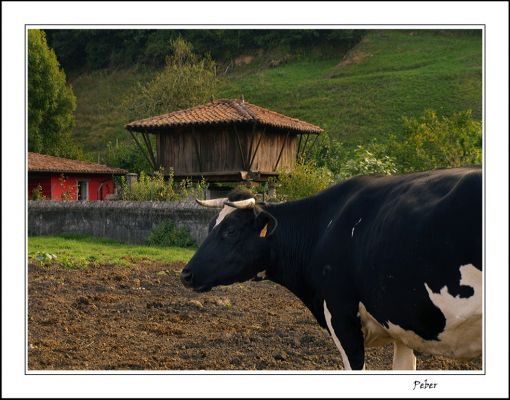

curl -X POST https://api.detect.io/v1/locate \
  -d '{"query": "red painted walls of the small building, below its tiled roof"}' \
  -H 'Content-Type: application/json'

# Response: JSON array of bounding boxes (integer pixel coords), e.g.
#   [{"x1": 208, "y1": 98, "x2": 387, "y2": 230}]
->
[{"x1": 28, "y1": 175, "x2": 115, "y2": 201}]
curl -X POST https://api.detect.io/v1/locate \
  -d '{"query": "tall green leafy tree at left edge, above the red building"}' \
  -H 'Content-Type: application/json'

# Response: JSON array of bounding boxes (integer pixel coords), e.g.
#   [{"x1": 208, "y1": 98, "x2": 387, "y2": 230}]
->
[{"x1": 28, "y1": 29, "x2": 81, "y2": 158}]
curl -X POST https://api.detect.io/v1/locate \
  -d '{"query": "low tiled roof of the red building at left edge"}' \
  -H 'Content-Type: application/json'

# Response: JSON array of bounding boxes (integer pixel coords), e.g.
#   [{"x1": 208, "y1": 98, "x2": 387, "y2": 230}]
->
[{"x1": 28, "y1": 152, "x2": 128, "y2": 175}]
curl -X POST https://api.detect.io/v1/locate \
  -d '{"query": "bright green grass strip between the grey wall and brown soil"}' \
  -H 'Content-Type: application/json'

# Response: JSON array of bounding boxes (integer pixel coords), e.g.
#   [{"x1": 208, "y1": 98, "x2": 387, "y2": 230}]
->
[{"x1": 28, "y1": 235, "x2": 195, "y2": 268}]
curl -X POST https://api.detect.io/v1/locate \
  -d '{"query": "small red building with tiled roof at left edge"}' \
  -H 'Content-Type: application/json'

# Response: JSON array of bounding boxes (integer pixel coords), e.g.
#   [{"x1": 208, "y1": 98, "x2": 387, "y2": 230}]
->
[{"x1": 28, "y1": 152, "x2": 128, "y2": 201}]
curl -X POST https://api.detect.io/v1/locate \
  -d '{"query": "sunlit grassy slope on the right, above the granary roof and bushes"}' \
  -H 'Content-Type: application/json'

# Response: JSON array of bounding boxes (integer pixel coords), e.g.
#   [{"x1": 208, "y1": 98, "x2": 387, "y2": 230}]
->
[{"x1": 222, "y1": 31, "x2": 482, "y2": 144}]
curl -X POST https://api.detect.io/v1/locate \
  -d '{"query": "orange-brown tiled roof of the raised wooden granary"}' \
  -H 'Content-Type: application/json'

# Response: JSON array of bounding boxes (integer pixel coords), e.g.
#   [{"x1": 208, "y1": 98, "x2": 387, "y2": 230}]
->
[{"x1": 126, "y1": 99, "x2": 323, "y2": 134}]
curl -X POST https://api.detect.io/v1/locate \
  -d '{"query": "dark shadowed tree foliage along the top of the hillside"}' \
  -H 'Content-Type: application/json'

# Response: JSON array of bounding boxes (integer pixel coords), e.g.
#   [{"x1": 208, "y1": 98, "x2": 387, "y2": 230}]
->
[{"x1": 46, "y1": 29, "x2": 365, "y2": 72}]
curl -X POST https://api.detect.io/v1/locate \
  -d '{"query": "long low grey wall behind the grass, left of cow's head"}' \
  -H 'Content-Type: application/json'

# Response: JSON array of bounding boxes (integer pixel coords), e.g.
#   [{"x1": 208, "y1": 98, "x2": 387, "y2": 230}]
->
[{"x1": 28, "y1": 201, "x2": 218, "y2": 244}]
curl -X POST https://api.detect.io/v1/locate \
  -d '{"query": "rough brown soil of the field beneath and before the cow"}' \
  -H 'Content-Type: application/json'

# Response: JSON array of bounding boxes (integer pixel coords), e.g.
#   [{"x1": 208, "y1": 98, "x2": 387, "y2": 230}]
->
[{"x1": 28, "y1": 263, "x2": 481, "y2": 370}]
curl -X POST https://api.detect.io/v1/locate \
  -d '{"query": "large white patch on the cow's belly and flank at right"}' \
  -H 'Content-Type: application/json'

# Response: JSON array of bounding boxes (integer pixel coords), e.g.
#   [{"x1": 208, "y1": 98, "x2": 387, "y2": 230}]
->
[{"x1": 387, "y1": 264, "x2": 482, "y2": 359}]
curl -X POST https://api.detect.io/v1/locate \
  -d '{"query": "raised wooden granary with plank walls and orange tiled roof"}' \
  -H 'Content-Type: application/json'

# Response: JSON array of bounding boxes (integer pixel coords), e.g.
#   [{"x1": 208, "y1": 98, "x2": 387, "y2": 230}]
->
[{"x1": 126, "y1": 99, "x2": 323, "y2": 182}]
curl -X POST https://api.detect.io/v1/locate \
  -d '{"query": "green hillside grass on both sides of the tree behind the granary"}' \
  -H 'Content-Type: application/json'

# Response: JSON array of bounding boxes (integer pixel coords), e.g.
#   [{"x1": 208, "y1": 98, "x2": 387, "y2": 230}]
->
[{"x1": 71, "y1": 30, "x2": 482, "y2": 157}]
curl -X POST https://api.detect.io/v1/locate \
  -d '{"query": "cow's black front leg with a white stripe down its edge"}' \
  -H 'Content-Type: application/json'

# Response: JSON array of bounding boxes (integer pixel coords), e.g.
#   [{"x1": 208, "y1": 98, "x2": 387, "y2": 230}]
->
[{"x1": 324, "y1": 301, "x2": 365, "y2": 370}]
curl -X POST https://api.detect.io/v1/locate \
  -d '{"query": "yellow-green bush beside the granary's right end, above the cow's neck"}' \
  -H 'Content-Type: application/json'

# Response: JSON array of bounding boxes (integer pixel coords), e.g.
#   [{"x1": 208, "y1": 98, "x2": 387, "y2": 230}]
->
[{"x1": 271, "y1": 161, "x2": 333, "y2": 201}]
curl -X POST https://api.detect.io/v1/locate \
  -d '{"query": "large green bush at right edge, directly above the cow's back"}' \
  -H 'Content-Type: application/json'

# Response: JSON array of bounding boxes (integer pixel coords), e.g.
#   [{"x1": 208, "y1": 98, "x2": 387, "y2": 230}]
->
[{"x1": 388, "y1": 110, "x2": 482, "y2": 172}]
